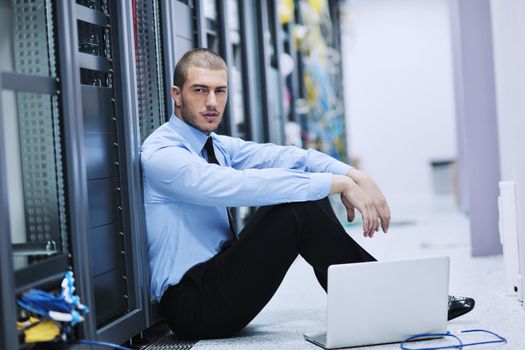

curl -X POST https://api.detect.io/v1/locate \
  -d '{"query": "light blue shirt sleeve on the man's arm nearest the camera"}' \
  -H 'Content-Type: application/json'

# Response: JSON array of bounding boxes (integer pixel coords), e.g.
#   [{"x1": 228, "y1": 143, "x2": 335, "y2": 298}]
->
[{"x1": 142, "y1": 147, "x2": 332, "y2": 207}]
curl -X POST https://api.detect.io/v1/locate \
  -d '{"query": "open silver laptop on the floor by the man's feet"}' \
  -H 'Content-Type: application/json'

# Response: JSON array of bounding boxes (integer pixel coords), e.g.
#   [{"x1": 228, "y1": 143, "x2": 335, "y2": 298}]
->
[{"x1": 304, "y1": 257, "x2": 450, "y2": 349}]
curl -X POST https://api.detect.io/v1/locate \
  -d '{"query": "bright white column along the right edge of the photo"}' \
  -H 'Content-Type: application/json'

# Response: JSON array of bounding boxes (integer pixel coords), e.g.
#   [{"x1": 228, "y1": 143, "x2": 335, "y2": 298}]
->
[{"x1": 491, "y1": 0, "x2": 525, "y2": 302}]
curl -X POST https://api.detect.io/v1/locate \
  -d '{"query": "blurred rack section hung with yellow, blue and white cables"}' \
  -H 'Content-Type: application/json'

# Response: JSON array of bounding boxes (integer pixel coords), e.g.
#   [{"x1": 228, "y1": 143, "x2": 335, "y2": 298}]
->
[{"x1": 280, "y1": 0, "x2": 347, "y2": 161}]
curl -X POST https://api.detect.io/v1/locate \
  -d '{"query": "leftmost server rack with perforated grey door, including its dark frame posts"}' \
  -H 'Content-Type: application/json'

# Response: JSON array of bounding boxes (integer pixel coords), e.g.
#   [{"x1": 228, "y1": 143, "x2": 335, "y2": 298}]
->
[{"x1": 0, "y1": 1, "x2": 70, "y2": 349}]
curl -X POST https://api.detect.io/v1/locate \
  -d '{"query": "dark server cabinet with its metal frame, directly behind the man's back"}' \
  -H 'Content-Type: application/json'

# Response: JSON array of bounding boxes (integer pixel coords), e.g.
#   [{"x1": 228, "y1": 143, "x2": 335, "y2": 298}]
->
[{"x1": 70, "y1": 0, "x2": 147, "y2": 342}]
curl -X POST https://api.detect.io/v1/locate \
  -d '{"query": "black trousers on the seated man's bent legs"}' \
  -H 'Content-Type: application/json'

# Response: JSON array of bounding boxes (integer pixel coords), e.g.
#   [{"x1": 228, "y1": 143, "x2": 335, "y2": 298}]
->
[{"x1": 160, "y1": 199, "x2": 375, "y2": 339}]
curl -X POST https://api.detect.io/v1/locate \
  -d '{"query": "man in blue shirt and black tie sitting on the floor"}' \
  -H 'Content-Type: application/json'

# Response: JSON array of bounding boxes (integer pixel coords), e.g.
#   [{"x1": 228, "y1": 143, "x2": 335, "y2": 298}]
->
[{"x1": 141, "y1": 49, "x2": 473, "y2": 339}]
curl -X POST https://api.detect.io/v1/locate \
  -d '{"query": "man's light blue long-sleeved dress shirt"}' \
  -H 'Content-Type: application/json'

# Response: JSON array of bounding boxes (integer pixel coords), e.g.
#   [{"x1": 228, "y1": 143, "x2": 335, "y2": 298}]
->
[{"x1": 141, "y1": 115, "x2": 351, "y2": 301}]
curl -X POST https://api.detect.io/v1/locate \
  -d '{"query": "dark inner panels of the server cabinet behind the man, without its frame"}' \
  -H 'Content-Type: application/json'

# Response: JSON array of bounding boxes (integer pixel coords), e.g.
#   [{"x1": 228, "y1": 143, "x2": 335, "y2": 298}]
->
[{"x1": 77, "y1": 1, "x2": 129, "y2": 328}]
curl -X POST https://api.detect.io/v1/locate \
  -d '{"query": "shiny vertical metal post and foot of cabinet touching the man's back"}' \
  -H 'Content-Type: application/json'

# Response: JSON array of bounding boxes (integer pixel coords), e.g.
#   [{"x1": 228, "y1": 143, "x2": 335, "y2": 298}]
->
[{"x1": 97, "y1": 1, "x2": 147, "y2": 342}]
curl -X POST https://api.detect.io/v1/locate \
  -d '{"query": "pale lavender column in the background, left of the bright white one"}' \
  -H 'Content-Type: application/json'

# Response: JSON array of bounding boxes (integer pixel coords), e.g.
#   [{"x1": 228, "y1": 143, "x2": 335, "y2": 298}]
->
[{"x1": 450, "y1": 0, "x2": 502, "y2": 256}]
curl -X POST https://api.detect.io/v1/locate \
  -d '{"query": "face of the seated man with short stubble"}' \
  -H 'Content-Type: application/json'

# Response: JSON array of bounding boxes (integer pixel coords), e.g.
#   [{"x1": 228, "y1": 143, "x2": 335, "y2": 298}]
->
[{"x1": 171, "y1": 67, "x2": 228, "y2": 134}]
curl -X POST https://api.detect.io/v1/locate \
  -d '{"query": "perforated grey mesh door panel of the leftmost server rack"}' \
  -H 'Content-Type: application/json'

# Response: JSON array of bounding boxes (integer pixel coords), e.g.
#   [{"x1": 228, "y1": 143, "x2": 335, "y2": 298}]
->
[{"x1": 3, "y1": 2, "x2": 69, "y2": 288}]
